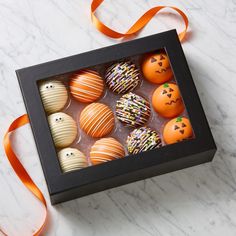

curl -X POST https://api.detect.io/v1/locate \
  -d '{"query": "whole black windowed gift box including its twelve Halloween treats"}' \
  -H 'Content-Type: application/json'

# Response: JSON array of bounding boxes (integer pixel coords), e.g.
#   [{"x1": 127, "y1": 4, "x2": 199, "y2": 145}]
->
[{"x1": 17, "y1": 30, "x2": 216, "y2": 204}]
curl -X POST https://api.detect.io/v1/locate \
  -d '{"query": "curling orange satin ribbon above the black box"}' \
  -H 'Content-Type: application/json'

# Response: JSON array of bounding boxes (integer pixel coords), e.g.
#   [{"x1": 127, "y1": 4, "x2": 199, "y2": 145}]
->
[{"x1": 91, "y1": 0, "x2": 188, "y2": 41}]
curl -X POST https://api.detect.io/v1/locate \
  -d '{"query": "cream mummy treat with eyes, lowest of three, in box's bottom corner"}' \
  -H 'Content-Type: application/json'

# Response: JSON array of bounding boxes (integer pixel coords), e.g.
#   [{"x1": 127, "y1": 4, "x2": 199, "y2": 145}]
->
[{"x1": 58, "y1": 148, "x2": 88, "y2": 173}]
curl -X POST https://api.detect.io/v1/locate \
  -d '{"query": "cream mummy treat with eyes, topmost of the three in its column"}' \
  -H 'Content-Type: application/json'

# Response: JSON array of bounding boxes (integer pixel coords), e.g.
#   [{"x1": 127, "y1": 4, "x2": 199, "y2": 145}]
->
[{"x1": 39, "y1": 80, "x2": 68, "y2": 113}]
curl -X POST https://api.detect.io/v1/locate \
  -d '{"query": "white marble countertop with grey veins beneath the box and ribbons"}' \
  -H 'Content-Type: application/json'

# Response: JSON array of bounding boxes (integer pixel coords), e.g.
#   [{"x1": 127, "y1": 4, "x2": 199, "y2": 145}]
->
[{"x1": 0, "y1": 0, "x2": 236, "y2": 236}]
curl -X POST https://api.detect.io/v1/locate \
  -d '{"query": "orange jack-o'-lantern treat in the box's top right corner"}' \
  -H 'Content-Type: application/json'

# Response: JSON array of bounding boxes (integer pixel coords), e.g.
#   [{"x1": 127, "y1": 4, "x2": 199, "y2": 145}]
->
[{"x1": 142, "y1": 52, "x2": 173, "y2": 84}]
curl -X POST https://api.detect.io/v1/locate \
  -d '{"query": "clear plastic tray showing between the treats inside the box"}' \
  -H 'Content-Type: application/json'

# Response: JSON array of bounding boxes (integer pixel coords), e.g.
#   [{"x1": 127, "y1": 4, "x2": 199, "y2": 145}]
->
[{"x1": 37, "y1": 48, "x2": 194, "y2": 171}]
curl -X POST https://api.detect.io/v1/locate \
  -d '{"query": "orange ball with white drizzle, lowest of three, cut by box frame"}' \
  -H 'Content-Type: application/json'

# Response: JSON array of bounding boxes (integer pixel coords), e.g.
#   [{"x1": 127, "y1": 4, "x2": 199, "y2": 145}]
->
[{"x1": 90, "y1": 138, "x2": 125, "y2": 165}]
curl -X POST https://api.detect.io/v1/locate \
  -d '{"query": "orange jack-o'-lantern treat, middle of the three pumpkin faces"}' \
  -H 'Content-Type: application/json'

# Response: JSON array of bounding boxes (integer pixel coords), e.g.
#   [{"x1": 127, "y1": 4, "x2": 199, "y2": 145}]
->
[{"x1": 152, "y1": 83, "x2": 184, "y2": 118}]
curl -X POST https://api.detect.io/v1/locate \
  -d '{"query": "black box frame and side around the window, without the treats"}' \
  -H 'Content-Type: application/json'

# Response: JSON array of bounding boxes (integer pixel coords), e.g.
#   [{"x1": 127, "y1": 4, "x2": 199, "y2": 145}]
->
[{"x1": 16, "y1": 30, "x2": 216, "y2": 204}]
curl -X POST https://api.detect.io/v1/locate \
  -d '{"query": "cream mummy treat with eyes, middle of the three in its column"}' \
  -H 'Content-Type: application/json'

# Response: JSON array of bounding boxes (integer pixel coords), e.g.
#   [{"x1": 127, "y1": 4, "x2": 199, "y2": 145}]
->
[{"x1": 48, "y1": 112, "x2": 78, "y2": 148}]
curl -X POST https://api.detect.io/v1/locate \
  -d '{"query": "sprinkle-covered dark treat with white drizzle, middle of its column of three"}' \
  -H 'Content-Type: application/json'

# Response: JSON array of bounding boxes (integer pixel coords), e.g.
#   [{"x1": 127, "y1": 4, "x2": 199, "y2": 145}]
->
[{"x1": 116, "y1": 92, "x2": 151, "y2": 127}]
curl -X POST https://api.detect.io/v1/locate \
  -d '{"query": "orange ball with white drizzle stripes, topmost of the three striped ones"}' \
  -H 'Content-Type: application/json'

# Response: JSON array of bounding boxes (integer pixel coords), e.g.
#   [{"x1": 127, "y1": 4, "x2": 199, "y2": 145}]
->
[{"x1": 69, "y1": 70, "x2": 104, "y2": 103}]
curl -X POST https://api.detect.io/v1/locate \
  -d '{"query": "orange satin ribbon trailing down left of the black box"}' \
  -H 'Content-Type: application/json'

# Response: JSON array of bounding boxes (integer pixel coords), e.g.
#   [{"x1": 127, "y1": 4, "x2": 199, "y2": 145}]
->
[{"x1": 3, "y1": 114, "x2": 47, "y2": 236}]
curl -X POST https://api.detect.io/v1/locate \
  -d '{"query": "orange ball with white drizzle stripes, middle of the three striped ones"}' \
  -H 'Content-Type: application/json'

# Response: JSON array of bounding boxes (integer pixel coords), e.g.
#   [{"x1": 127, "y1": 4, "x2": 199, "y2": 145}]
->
[{"x1": 80, "y1": 103, "x2": 115, "y2": 138}]
